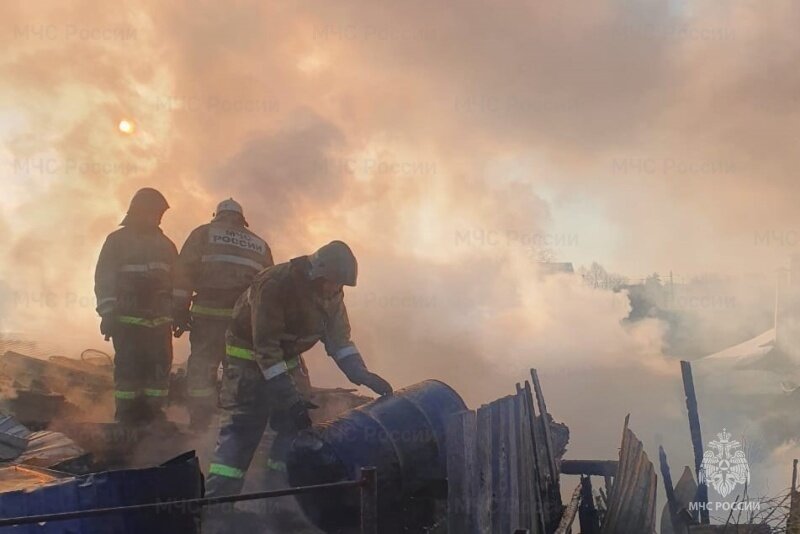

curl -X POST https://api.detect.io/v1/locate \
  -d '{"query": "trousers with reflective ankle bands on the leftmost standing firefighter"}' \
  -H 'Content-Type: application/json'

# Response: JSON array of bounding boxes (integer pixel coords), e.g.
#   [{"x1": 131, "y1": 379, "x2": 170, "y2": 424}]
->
[{"x1": 113, "y1": 316, "x2": 172, "y2": 423}]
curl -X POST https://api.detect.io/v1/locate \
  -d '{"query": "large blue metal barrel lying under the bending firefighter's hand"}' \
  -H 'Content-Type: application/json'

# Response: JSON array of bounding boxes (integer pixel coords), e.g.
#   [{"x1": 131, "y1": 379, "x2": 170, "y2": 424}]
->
[{"x1": 287, "y1": 380, "x2": 467, "y2": 532}]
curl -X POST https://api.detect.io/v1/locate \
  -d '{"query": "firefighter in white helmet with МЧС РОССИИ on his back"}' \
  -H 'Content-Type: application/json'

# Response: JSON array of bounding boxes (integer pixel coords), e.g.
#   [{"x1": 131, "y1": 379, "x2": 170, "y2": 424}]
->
[{"x1": 173, "y1": 198, "x2": 273, "y2": 431}]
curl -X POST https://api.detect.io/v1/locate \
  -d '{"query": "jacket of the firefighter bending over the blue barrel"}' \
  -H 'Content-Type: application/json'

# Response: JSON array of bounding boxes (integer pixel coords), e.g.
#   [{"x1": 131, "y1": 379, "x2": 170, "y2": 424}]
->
[{"x1": 226, "y1": 256, "x2": 358, "y2": 380}]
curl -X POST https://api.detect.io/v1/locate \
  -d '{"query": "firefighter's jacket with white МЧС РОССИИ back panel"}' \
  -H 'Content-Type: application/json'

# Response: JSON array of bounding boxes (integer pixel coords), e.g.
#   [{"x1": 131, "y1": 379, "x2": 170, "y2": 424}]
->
[{"x1": 174, "y1": 220, "x2": 273, "y2": 319}]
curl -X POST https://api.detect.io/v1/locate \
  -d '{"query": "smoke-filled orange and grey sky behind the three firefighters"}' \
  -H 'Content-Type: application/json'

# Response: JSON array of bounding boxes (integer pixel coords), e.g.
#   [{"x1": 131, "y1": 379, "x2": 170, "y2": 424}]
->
[{"x1": 0, "y1": 0, "x2": 800, "y2": 510}]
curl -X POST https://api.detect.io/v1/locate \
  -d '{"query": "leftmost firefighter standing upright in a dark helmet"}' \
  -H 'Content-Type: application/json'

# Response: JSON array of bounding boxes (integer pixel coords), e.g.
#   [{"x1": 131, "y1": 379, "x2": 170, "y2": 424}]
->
[{"x1": 95, "y1": 187, "x2": 178, "y2": 424}]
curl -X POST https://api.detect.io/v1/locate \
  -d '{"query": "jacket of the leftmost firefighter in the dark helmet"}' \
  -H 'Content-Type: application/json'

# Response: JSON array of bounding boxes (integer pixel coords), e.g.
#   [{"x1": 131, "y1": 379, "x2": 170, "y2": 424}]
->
[{"x1": 94, "y1": 225, "x2": 178, "y2": 327}]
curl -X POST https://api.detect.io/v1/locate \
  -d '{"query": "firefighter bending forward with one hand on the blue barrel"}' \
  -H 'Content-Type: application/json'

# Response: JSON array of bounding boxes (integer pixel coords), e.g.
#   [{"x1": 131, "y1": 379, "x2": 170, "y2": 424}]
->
[{"x1": 206, "y1": 241, "x2": 392, "y2": 495}]
